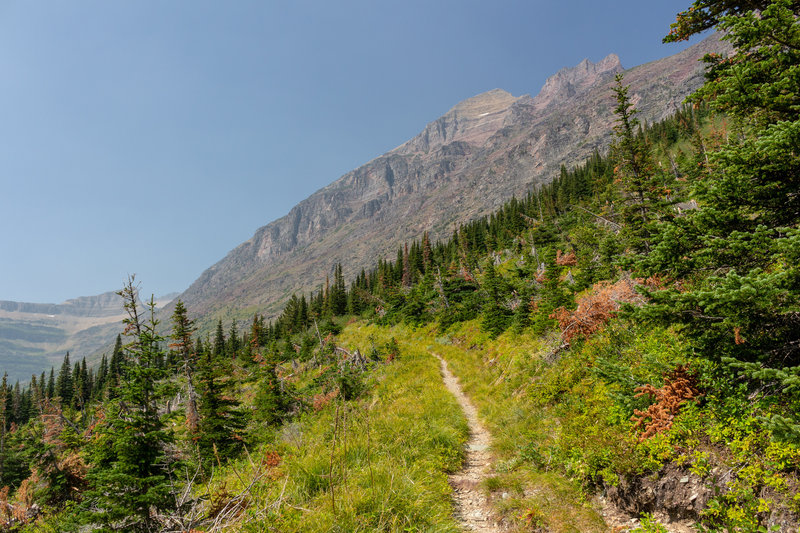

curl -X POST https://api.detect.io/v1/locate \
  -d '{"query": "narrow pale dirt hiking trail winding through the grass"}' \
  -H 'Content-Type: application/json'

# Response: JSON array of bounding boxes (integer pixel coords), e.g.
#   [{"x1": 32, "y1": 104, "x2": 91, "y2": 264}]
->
[{"x1": 431, "y1": 352, "x2": 504, "y2": 533}]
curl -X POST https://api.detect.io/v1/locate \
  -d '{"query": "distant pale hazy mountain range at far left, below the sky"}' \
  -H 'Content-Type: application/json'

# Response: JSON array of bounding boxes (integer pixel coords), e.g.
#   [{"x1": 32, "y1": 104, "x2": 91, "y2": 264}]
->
[{"x1": 0, "y1": 292, "x2": 177, "y2": 383}]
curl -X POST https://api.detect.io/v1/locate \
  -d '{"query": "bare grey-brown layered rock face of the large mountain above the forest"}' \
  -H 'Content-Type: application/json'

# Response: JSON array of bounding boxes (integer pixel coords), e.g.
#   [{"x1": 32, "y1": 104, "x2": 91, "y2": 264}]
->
[{"x1": 181, "y1": 36, "x2": 724, "y2": 321}]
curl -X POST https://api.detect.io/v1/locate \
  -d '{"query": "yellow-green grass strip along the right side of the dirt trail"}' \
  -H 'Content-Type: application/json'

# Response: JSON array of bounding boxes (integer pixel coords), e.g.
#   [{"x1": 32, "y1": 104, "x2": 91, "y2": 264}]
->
[{"x1": 343, "y1": 321, "x2": 616, "y2": 532}]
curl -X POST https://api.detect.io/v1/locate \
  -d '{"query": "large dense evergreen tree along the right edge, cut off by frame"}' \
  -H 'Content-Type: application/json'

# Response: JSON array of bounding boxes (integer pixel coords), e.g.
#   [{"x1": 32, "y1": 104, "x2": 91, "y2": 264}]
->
[{"x1": 641, "y1": 0, "x2": 800, "y2": 442}]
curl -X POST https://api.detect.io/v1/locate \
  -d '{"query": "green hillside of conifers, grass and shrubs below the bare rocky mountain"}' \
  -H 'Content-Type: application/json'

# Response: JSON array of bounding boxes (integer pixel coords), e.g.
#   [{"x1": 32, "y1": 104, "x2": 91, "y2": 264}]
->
[{"x1": 0, "y1": 0, "x2": 800, "y2": 532}]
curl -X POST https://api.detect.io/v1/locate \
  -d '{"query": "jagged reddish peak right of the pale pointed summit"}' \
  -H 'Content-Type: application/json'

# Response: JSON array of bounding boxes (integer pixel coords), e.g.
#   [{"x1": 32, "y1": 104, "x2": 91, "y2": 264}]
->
[{"x1": 533, "y1": 54, "x2": 623, "y2": 109}]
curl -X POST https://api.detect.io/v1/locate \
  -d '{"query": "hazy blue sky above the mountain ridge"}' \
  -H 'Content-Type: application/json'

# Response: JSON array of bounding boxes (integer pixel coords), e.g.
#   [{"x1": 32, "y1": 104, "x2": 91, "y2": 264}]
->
[{"x1": 0, "y1": 0, "x2": 708, "y2": 302}]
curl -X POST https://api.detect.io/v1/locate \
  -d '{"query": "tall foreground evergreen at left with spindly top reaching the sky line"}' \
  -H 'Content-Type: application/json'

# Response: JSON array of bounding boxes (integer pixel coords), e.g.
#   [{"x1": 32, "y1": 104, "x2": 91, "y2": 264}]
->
[{"x1": 83, "y1": 277, "x2": 175, "y2": 532}]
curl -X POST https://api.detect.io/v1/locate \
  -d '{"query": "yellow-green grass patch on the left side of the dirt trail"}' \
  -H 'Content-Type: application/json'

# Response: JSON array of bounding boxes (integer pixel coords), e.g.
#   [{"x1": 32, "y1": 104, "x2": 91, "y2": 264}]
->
[{"x1": 203, "y1": 324, "x2": 468, "y2": 532}]
